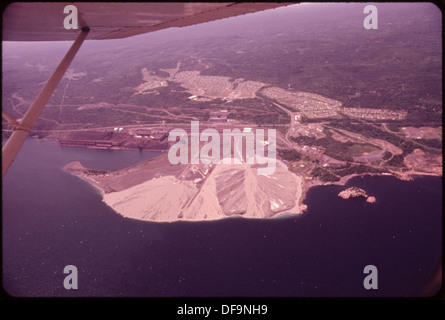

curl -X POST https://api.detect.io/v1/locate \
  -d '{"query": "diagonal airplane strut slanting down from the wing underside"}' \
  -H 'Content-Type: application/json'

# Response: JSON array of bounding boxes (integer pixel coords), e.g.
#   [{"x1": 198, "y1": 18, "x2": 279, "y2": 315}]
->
[{"x1": 2, "y1": 27, "x2": 89, "y2": 177}]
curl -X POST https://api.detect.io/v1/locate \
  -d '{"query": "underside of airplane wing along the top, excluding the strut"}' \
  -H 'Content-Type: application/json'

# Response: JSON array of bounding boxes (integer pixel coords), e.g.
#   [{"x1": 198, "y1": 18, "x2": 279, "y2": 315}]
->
[{"x1": 3, "y1": 2, "x2": 291, "y2": 41}]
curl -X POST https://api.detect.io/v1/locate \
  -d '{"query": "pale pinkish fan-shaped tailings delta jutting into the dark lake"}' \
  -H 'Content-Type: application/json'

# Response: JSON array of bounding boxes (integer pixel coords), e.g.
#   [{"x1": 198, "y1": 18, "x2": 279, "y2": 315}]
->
[{"x1": 64, "y1": 154, "x2": 302, "y2": 222}]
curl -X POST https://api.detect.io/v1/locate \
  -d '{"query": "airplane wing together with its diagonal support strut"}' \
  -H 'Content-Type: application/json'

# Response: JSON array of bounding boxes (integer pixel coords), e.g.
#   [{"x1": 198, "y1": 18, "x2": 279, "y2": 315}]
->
[{"x1": 2, "y1": 2, "x2": 291, "y2": 177}]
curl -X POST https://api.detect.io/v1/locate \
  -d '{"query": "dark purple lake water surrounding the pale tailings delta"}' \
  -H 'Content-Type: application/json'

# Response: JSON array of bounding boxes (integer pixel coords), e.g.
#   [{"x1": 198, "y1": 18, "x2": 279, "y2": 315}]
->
[{"x1": 2, "y1": 139, "x2": 442, "y2": 297}]
